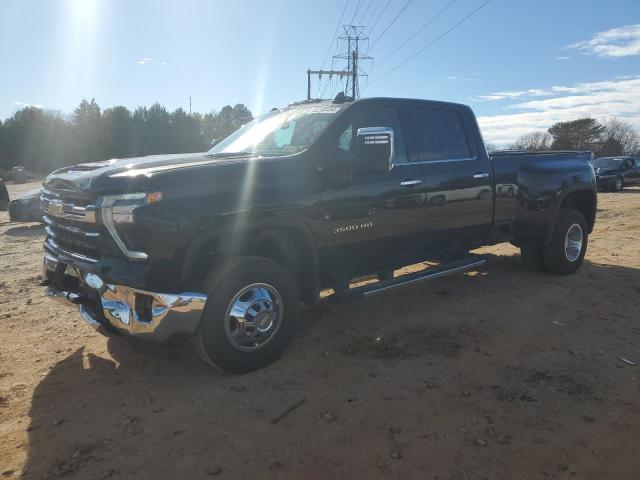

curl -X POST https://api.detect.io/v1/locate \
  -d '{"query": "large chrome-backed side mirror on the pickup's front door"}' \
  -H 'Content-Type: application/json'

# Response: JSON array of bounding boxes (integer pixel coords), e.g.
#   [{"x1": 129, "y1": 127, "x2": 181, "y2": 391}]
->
[{"x1": 352, "y1": 127, "x2": 393, "y2": 173}]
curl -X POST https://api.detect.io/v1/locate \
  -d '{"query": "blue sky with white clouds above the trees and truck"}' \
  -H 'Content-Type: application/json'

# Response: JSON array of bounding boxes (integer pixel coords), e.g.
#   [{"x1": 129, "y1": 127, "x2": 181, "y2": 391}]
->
[{"x1": 0, "y1": 0, "x2": 640, "y2": 145}]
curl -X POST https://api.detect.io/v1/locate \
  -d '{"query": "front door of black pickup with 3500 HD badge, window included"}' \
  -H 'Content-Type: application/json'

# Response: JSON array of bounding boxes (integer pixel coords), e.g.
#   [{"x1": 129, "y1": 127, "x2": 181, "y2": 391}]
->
[{"x1": 323, "y1": 106, "x2": 426, "y2": 278}]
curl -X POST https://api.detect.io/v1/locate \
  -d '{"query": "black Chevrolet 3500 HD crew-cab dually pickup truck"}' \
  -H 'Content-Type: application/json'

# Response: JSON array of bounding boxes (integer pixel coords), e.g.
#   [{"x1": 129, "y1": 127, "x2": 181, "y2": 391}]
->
[{"x1": 41, "y1": 97, "x2": 596, "y2": 372}]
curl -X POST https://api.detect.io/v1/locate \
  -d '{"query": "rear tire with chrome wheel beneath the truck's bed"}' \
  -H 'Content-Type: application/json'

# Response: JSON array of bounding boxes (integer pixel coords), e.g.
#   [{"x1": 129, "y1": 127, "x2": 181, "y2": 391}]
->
[{"x1": 542, "y1": 208, "x2": 589, "y2": 275}]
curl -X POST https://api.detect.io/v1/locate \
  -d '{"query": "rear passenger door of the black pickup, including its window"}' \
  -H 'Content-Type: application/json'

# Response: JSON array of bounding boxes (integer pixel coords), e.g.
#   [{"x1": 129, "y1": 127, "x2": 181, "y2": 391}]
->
[{"x1": 398, "y1": 104, "x2": 494, "y2": 253}]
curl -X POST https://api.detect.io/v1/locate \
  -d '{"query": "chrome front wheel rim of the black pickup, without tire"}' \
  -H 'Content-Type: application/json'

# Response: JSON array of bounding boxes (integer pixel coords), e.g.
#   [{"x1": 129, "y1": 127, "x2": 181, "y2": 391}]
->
[{"x1": 224, "y1": 283, "x2": 284, "y2": 352}]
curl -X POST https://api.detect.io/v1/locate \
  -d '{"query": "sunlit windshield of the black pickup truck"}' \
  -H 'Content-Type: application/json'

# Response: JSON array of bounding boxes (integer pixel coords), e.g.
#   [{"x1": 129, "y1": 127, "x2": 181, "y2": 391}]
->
[{"x1": 209, "y1": 104, "x2": 341, "y2": 156}]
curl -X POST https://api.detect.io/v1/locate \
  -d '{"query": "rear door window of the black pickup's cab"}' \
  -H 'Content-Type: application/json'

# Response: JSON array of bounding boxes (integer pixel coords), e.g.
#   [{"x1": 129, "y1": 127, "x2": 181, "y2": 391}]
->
[{"x1": 408, "y1": 108, "x2": 472, "y2": 162}]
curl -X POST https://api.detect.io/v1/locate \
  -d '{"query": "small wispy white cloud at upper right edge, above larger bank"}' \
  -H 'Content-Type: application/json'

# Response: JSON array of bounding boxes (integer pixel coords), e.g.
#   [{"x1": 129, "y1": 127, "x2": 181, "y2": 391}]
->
[{"x1": 567, "y1": 24, "x2": 640, "y2": 57}]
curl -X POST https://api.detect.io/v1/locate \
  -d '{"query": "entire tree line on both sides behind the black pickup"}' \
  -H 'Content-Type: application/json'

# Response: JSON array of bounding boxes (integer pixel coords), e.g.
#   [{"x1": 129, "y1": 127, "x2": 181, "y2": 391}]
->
[{"x1": 0, "y1": 99, "x2": 640, "y2": 176}]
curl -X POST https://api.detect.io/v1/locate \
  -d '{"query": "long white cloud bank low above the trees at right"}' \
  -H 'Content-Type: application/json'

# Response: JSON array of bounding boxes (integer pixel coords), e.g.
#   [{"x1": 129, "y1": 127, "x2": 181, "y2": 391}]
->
[{"x1": 478, "y1": 75, "x2": 640, "y2": 144}]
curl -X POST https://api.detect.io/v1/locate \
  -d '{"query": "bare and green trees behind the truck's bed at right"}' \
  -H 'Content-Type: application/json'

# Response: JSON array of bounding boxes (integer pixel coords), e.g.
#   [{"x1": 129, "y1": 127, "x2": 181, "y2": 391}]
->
[{"x1": 510, "y1": 118, "x2": 640, "y2": 157}]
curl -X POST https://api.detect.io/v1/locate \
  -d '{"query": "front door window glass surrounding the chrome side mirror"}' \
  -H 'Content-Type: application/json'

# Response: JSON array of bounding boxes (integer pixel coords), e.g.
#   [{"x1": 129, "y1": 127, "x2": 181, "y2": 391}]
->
[{"x1": 338, "y1": 107, "x2": 407, "y2": 163}]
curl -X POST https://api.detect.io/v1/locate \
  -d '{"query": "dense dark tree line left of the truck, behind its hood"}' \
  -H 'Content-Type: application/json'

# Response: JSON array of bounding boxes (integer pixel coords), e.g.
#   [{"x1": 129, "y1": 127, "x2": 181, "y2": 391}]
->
[{"x1": 0, "y1": 99, "x2": 253, "y2": 175}]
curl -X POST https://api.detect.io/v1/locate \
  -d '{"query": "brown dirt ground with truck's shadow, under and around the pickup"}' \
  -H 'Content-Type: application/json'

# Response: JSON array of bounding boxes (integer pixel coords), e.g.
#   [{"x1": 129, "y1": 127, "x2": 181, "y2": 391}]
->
[{"x1": 0, "y1": 184, "x2": 640, "y2": 480}]
